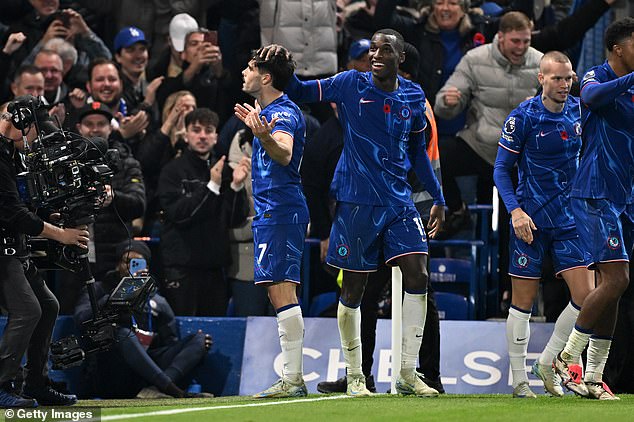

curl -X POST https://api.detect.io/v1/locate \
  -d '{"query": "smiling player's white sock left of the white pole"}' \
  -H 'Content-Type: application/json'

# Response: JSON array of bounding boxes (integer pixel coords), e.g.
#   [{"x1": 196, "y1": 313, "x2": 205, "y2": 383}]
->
[{"x1": 337, "y1": 302, "x2": 363, "y2": 377}]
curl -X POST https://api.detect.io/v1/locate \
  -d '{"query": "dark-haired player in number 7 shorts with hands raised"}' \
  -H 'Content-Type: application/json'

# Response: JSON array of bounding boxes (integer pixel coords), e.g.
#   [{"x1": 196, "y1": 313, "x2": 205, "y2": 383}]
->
[{"x1": 235, "y1": 47, "x2": 308, "y2": 398}]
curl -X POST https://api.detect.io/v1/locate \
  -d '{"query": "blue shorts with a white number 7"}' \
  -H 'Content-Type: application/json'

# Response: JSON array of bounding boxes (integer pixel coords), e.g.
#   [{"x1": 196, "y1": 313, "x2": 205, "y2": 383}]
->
[{"x1": 253, "y1": 224, "x2": 307, "y2": 284}]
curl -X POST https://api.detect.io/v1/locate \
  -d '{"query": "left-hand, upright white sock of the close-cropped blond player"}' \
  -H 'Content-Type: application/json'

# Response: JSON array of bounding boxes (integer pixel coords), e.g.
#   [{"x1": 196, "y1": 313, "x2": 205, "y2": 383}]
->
[{"x1": 506, "y1": 306, "x2": 531, "y2": 388}]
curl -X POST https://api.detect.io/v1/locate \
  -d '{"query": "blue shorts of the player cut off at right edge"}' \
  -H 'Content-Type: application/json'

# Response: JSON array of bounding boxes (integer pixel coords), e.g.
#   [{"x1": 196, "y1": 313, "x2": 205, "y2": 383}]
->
[{"x1": 570, "y1": 198, "x2": 634, "y2": 268}]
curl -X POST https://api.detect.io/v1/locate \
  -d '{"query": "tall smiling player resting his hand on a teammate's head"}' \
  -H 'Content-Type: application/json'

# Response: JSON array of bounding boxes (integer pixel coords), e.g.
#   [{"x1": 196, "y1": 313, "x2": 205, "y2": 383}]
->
[{"x1": 256, "y1": 29, "x2": 444, "y2": 396}]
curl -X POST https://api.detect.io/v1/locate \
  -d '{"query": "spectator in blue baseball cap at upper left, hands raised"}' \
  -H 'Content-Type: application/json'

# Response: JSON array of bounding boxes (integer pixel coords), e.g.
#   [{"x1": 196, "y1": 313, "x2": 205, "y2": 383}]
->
[{"x1": 114, "y1": 26, "x2": 163, "y2": 113}]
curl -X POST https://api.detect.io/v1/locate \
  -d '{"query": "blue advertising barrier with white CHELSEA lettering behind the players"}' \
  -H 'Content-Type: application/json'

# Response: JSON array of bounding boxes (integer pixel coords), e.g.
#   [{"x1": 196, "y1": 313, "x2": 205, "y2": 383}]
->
[{"x1": 0, "y1": 316, "x2": 553, "y2": 396}]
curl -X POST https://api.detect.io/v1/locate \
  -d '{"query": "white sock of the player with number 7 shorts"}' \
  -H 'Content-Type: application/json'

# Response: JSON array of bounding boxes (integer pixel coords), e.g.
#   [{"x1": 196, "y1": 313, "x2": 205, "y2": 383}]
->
[{"x1": 277, "y1": 305, "x2": 304, "y2": 383}]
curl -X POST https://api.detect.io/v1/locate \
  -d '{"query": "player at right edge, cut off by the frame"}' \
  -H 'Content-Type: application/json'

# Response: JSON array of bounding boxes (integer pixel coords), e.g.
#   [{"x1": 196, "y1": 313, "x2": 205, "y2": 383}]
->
[{"x1": 553, "y1": 17, "x2": 634, "y2": 400}]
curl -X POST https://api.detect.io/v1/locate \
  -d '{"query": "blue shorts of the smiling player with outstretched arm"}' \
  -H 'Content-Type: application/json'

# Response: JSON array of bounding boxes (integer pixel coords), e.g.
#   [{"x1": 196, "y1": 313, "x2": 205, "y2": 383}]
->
[{"x1": 326, "y1": 202, "x2": 427, "y2": 272}]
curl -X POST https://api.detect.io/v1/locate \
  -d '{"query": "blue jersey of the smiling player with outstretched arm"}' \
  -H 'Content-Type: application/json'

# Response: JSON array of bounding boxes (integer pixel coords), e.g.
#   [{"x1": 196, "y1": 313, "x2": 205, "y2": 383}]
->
[{"x1": 289, "y1": 70, "x2": 428, "y2": 206}]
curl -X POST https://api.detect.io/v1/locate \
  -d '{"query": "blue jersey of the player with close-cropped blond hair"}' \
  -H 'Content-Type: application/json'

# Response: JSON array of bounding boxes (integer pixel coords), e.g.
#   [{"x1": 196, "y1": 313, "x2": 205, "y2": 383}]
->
[{"x1": 499, "y1": 96, "x2": 581, "y2": 228}]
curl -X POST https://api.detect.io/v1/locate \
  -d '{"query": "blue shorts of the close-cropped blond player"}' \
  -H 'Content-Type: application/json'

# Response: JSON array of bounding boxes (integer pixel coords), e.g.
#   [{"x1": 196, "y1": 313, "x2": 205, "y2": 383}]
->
[{"x1": 509, "y1": 223, "x2": 587, "y2": 278}]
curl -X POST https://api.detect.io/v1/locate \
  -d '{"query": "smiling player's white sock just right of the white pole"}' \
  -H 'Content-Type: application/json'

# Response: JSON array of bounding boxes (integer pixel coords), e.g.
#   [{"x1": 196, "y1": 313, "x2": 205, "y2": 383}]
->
[{"x1": 401, "y1": 292, "x2": 427, "y2": 381}]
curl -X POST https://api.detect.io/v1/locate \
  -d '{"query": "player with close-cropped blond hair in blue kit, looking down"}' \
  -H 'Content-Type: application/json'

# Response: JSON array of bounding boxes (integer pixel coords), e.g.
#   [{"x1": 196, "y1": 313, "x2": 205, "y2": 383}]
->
[{"x1": 493, "y1": 51, "x2": 594, "y2": 398}]
